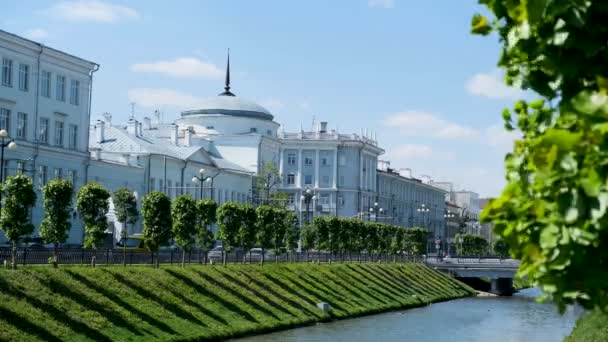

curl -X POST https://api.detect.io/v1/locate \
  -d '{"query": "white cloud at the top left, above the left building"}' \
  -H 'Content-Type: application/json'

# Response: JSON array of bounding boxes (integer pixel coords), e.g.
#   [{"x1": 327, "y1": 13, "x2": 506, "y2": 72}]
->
[{"x1": 50, "y1": 0, "x2": 139, "y2": 23}]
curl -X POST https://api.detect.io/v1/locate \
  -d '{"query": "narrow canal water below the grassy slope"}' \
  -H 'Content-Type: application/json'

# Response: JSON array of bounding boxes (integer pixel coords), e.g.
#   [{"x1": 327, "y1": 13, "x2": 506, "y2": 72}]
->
[{"x1": 239, "y1": 289, "x2": 583, "y2": 342}]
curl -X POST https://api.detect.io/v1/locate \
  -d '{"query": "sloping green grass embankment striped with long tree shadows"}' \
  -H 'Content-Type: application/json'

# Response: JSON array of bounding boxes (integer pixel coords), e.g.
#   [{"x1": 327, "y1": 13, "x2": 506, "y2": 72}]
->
[{"x1": 0, "y1": 264, "x2": 474, "y2": 341}]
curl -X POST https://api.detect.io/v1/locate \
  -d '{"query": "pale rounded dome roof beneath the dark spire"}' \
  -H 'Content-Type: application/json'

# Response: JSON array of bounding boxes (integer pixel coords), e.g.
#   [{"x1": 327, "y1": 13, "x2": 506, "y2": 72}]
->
[{"x1": 182, "y1": 96, "x2": 274, "y2": 121}]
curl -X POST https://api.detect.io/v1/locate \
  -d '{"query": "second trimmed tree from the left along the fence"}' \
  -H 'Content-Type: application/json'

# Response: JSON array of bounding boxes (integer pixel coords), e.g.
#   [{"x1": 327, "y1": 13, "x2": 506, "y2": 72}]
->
[{"x1": 40, "y1": 179, "x2": 74, "y2": 266}]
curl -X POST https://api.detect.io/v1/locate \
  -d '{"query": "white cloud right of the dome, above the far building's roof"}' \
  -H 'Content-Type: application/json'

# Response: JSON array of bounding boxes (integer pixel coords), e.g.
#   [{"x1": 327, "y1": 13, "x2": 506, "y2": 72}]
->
[{"x1": 384, "y1": 111, "x2": 479, "y2": 139}]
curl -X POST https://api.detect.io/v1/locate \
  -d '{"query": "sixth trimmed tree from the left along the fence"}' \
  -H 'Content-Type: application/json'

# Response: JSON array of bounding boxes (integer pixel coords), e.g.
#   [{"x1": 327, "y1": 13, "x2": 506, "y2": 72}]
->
[{"x1": 171, "y1": 195, "x2": 198, "y2": 267}]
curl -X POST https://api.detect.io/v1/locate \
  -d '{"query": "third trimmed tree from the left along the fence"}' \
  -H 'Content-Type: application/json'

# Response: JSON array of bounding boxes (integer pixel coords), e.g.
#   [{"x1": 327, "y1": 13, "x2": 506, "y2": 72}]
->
[{"x1": 76, "y1": 182, "x2": 114, "y2": 267}]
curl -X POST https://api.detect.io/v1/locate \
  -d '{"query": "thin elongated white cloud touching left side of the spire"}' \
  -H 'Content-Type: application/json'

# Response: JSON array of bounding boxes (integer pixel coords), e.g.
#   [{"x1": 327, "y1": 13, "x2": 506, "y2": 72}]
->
[{"x1": 131, "y1": 57, "x2": 223, "y2": 79}]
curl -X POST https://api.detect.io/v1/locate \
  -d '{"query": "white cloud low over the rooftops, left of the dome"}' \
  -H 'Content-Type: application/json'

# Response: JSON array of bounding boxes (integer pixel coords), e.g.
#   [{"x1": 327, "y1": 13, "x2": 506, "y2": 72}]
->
[{"x1": 128, "y1": 88, "x2": 202, "y2": 108}]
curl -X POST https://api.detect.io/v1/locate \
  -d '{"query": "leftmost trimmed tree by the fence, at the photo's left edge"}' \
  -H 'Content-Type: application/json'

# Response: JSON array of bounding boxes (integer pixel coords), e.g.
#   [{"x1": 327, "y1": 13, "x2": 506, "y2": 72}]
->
[{"x1": 0, "y1": 175, "x2": 36, "y2": 269}]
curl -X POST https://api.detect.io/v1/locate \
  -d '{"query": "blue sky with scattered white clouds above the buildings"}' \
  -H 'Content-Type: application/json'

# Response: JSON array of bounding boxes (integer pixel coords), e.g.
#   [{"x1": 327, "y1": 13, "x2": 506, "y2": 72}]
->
[{"x1": 0, "y1": 0, "x2": 523, "y2": 197}]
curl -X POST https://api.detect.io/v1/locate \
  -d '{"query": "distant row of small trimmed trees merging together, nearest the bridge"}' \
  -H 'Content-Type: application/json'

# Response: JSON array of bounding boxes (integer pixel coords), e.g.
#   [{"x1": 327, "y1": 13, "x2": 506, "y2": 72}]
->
[{"x1": 302, "y1": 216, "x2": 429, "y2": 255}]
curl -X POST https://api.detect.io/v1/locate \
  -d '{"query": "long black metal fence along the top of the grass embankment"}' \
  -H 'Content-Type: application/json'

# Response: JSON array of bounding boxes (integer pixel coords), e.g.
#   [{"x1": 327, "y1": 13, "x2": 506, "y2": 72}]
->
[{"x1": 0, "y1": 248, "x2": 424, "y2": 265}]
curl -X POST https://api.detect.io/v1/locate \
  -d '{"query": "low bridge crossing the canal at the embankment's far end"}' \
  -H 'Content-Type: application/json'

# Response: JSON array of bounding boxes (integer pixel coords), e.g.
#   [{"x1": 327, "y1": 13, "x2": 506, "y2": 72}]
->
[{"x1": 425, "y1": 257, "x2": 519, "y2": 296}]
